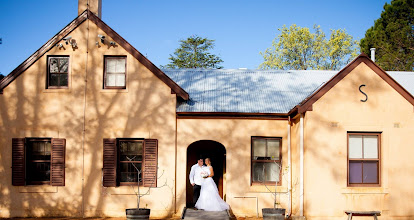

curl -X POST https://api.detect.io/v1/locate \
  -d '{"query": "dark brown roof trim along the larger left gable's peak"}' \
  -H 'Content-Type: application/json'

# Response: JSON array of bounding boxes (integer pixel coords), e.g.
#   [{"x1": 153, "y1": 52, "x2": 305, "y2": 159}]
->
[{"x1": 0, "y1": 10, "x2": 189, "y2": 100}]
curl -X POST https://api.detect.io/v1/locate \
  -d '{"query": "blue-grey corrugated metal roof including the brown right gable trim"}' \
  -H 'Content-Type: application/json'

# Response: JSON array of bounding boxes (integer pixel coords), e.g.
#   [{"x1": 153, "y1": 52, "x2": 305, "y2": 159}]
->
[{"x1": 163, "y1": 54, "x2": 414, "y2": 117}]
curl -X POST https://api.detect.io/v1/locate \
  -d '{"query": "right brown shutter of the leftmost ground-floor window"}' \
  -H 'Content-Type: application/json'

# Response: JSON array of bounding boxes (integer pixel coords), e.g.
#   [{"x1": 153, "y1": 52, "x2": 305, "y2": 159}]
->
[{"x1": 50, "y1": 138, "x2": 66, "y2": 186}]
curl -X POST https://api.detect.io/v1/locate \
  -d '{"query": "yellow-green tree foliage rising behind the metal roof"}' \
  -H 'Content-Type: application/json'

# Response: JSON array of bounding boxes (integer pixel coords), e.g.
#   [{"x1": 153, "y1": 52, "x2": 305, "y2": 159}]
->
[{"x1": 259, "y1": 24, "x2": 358, "y2": 70}]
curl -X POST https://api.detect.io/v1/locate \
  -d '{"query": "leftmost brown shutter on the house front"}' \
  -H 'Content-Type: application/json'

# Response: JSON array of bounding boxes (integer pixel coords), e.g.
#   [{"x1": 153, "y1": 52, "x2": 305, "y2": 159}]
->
[{"x1": 12, "y1": 138, "x2": 25, "y2": 186}]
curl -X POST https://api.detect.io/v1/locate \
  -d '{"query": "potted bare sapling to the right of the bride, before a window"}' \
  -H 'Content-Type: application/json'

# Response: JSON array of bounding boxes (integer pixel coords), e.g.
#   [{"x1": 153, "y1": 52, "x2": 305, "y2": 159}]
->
[{"x1": 262, "y1": 156, "x2": 289, "y2": 220}]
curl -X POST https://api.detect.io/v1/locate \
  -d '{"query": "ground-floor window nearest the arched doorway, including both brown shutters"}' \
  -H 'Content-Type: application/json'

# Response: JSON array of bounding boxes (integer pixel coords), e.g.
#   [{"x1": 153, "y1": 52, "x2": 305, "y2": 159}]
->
[{"x1": 103, "y1": 138, "x2": 158, "y2": 187}]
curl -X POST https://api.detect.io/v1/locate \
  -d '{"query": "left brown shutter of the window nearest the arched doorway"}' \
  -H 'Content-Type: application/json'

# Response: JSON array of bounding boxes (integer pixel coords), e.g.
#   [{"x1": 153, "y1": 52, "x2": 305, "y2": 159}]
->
[{"x1": 103, "y1": 138, "x2": 117, "y2": 187}]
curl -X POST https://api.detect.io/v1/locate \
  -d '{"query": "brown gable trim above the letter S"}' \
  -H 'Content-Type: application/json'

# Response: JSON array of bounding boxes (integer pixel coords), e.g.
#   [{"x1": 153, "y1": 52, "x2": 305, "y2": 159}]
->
[{"x1": 292, "y1": 53, "x2": 414, "y2": 114}]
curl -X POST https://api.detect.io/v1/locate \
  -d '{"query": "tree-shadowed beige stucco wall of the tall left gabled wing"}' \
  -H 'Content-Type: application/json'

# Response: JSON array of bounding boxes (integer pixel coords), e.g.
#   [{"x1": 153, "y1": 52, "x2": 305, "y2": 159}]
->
[{"x1": 0, "y1": 21, "x2": 176, "y2": 217}]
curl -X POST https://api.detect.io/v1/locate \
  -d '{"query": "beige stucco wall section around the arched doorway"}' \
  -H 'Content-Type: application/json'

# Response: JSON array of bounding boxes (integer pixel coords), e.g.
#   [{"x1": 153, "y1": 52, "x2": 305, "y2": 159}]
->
[{"x1": 177, "y1": 119, "x2": 288, "y2": 216}]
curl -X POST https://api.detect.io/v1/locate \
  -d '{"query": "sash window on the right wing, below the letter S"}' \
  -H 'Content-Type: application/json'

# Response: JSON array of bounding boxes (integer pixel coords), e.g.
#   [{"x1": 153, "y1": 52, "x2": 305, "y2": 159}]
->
[{"x1": 348, "y1": 133, "x2": 381, "y2": 186}]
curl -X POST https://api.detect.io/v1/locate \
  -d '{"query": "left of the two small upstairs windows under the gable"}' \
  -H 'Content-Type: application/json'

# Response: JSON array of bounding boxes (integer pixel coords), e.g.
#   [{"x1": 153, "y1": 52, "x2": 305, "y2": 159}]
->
[{"x1": 47, "y1": 56, "x2": 69, "y2": 89}]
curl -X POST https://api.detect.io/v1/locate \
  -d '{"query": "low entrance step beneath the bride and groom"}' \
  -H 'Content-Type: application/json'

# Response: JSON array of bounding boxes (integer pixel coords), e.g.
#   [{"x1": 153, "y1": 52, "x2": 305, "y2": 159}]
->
[{"x1": 181, "y1": 208, "x2": 235, "y2": 220}]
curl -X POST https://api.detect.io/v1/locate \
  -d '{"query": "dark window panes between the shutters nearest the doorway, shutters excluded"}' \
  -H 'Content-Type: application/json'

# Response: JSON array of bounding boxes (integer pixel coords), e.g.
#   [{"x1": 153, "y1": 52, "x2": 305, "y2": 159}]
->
[{"x1": 118, "y1": 140, "x2": 144, "y2": 185}]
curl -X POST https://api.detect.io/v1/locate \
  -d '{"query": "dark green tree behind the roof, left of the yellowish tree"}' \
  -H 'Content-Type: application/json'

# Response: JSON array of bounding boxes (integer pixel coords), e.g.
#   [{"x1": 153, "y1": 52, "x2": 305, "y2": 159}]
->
[{"x1": 162, "y1": 35, "x2": 223, "y2": 69}]
